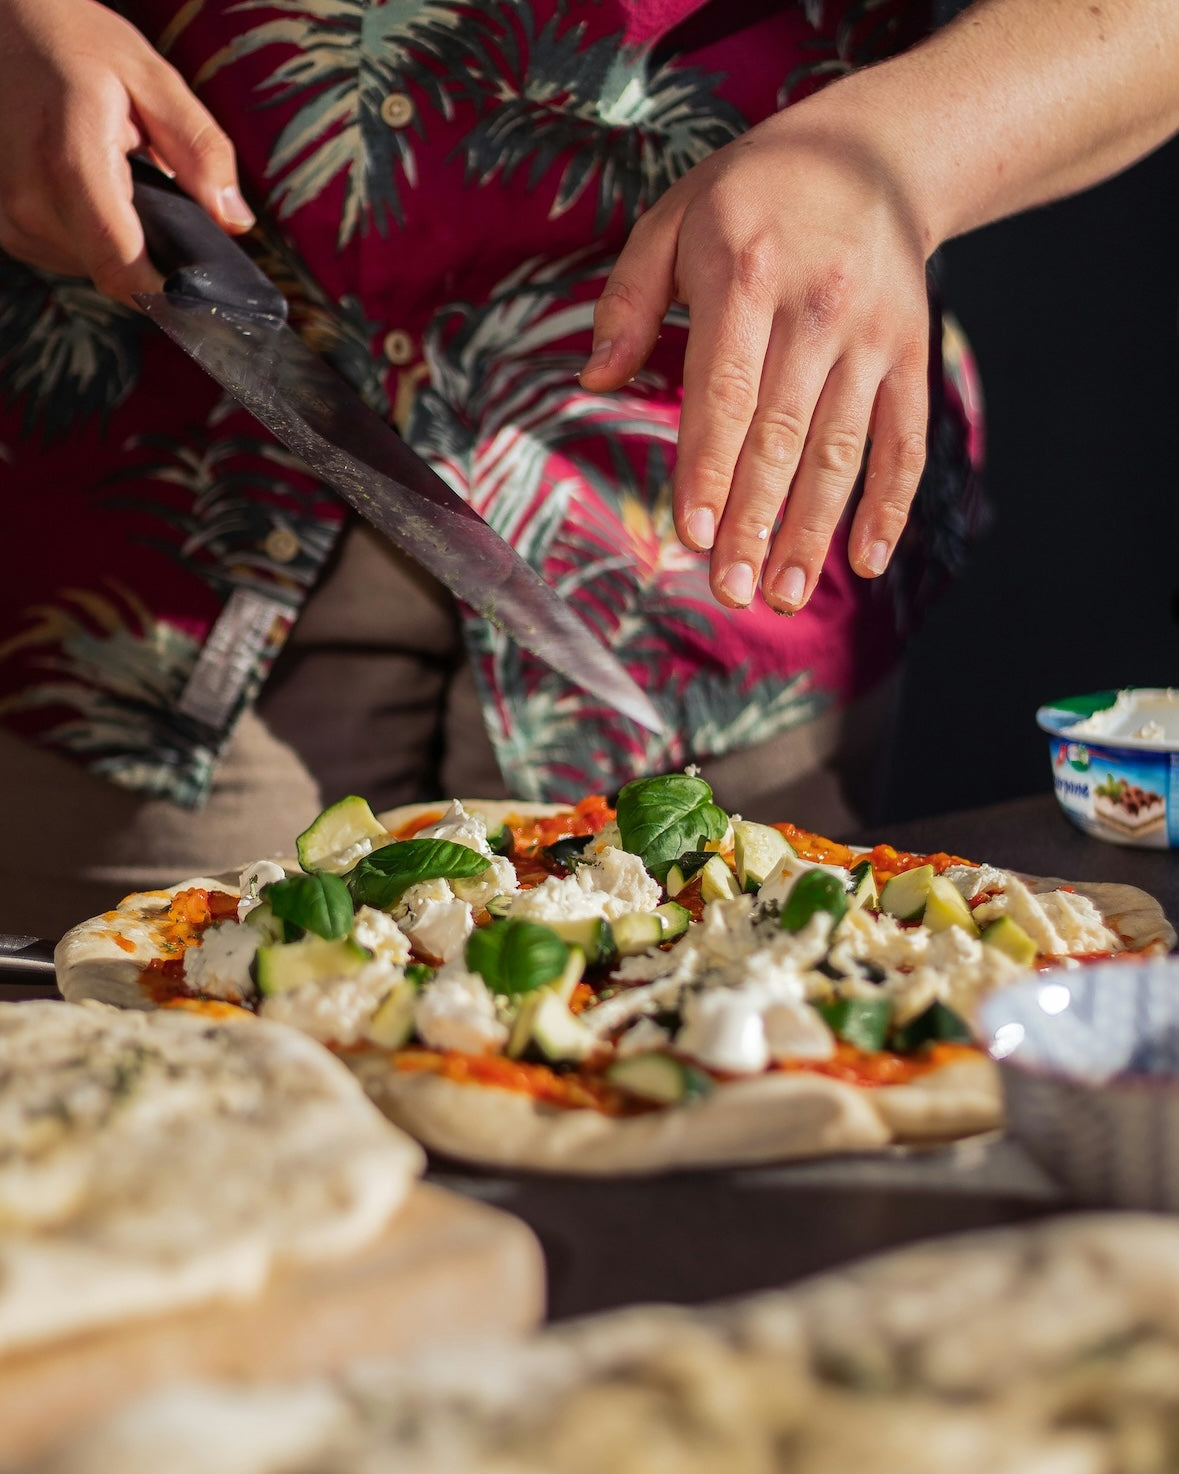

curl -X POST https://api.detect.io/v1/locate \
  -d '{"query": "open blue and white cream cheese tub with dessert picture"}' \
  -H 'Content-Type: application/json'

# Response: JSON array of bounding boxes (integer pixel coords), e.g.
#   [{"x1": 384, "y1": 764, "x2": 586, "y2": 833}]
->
[{"x1": 1036, "y1": 685, "x2": 1179, "y2": 849}]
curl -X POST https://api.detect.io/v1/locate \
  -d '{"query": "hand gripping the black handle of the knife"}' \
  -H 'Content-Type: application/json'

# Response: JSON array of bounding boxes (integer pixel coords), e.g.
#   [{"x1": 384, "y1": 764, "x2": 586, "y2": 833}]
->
[{"x1": 0, "y1": 0, "x2": 253, "y2": 304}]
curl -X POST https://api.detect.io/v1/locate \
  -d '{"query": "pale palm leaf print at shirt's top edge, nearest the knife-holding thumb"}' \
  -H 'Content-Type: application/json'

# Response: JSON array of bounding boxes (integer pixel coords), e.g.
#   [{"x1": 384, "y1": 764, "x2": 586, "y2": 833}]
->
[{"x1": 196, "y1": 0, "x2": 464, "y2": 246}]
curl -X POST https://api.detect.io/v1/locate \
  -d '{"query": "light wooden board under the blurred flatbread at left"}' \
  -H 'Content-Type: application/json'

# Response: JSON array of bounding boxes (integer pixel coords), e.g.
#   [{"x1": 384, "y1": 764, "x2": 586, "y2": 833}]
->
[{"x1": 0, "y1": 1184, "x2": 544, "y2": 1468}]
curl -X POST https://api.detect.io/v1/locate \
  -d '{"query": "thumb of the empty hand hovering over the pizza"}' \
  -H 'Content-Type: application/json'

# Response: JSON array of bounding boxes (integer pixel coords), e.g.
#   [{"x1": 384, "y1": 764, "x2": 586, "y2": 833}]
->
[{"x1": 579, "y1": 211, "x2": 679, "y2": 389}]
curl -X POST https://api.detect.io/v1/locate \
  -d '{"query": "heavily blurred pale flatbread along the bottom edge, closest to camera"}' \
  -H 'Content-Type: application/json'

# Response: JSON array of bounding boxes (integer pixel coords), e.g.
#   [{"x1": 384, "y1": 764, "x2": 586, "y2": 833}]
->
[{"x1": 29, "y1": 1215, "x2": 1179, "y2": 1474}]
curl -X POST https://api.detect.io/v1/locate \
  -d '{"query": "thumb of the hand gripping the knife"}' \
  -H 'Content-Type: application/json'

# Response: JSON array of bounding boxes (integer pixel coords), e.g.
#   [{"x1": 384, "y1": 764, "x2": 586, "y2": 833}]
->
[{"x1": 134, "y1": 60, "x2": 253, "y2": 236}]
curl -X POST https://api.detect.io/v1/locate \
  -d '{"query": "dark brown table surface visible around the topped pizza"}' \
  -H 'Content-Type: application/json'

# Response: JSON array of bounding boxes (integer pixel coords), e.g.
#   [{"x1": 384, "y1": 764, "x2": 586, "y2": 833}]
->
[{"x1": 0, "y1": 794, "x2": 1179, "y2": 1318}]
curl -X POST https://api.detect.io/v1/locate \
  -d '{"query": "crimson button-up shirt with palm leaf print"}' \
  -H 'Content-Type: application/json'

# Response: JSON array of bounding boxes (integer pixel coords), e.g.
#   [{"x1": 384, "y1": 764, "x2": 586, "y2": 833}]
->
[{"x1": 0, "y1": 0, "x2": 977, "y2": 805}]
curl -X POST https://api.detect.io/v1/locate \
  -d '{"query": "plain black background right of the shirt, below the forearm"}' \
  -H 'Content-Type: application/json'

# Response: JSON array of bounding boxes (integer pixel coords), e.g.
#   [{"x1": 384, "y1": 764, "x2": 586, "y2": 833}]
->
[{"x1": 880, "y1": 131, "x2": 1179, "y2": 821}]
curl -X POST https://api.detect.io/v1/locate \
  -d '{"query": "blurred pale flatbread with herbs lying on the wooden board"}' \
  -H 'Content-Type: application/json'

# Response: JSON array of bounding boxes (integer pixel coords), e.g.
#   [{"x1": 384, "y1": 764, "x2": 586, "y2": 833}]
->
[{"x1": 0, "y1": 1001, "x2": 423, "y2": 1353}]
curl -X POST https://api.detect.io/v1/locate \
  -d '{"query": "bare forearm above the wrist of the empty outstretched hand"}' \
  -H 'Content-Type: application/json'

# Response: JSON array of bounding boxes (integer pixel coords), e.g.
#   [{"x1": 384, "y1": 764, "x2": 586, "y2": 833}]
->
[{"x1": 790, "y1": 0, "x2": 1179, "y2": 254}]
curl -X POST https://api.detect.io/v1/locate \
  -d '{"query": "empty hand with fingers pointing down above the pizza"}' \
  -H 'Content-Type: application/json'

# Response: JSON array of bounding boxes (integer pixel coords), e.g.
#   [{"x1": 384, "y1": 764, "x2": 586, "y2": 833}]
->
[{"x1": 582, "y1": 109, "x2": 928, "y2": 613}]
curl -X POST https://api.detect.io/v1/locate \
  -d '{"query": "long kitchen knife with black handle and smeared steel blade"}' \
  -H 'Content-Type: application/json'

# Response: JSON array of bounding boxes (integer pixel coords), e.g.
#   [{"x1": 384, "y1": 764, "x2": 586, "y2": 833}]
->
[{"x1": 131, "y1": 159, "x2": 665, "y2": 733}]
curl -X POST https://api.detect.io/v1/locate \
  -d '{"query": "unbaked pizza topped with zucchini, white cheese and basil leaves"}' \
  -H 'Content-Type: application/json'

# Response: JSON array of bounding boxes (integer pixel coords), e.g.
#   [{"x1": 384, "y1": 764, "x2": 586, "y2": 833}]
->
[{"x1": 56, "y1": 769, "x2": 1175, "y2": 1173}]
